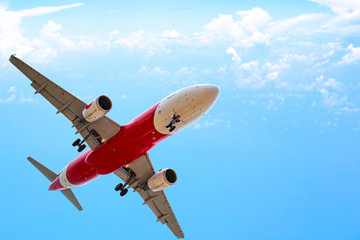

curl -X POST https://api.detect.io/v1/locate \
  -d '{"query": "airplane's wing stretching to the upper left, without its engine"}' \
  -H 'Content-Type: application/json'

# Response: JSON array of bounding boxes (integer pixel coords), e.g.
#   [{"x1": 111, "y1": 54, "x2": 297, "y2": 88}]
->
[{"x1": 9, "y1": 55, "x2": 121, "y2": 149}]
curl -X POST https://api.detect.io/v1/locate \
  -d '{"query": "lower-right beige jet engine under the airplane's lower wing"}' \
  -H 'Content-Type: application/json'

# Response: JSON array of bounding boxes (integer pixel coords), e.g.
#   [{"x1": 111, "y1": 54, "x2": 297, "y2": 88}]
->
[{"x1": 148, "y1": 168, "x2": 177, "y2": 192}]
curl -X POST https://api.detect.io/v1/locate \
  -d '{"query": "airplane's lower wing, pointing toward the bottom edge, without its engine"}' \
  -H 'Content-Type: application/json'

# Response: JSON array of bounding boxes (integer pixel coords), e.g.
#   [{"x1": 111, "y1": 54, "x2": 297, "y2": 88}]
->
[{"x1": 114, "y1": 155, "x2": 184, "y2": 238}]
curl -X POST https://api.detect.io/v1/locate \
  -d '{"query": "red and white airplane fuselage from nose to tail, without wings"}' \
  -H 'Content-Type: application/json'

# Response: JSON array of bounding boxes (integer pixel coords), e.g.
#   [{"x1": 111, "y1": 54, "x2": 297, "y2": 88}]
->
[{"x1": 49, "y1": 84, "x2": 219, "y2": 190}]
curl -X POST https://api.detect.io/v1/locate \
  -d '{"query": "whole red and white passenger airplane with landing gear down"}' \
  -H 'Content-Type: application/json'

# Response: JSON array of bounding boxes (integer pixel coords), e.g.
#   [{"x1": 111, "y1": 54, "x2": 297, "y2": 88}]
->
[{"x1": 9, "y1": 55, "x2": 219, "y2": 238}]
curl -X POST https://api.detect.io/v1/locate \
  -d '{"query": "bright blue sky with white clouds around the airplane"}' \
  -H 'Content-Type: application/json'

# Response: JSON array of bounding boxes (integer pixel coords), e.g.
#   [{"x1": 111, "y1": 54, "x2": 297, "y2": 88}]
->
[{"x1": 0, "y1": 0, "x2": 360, "y2": 239}]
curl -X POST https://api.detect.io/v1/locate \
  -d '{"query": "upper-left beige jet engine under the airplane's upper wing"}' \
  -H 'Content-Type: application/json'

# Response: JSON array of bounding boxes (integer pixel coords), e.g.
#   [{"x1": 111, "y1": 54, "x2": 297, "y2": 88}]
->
[{"x1": 82, "y1": 95, "x2": 112, "y2": 122}]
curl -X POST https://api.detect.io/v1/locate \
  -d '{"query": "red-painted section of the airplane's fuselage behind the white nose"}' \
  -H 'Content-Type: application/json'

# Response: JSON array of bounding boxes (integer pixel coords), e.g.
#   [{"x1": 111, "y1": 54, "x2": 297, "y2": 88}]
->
[{"x1": 49, "y1": 104, "x2": 171, "y2": 190}]
